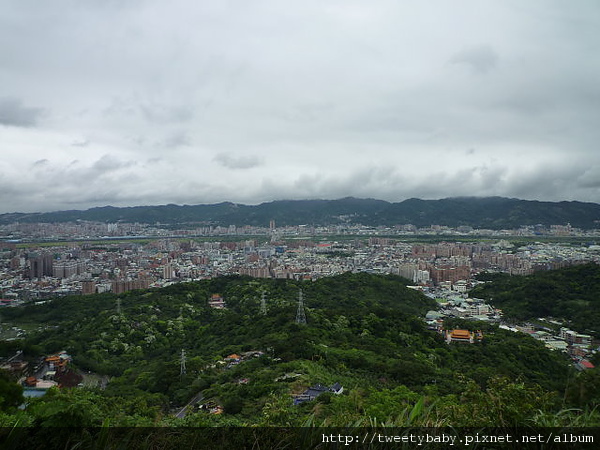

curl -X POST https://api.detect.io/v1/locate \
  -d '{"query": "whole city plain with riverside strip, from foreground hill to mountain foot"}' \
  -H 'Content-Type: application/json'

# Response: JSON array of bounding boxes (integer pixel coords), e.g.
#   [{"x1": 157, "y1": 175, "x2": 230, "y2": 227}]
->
[{"x1": 0, "y1": 221, "x2": 600, "y2": 304}]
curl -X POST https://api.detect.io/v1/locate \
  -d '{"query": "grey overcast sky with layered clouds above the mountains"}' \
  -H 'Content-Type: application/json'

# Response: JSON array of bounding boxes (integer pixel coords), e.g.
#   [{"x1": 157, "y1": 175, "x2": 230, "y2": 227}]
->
[{"x1": 0, "y1": 0, "x2": 600, "y2": 213}]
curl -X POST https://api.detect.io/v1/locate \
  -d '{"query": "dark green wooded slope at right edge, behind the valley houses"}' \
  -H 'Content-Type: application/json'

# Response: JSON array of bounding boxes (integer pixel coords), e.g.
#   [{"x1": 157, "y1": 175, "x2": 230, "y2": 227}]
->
[{"x1": 471, "y1": 264, "x2": 600, "y2": 337}]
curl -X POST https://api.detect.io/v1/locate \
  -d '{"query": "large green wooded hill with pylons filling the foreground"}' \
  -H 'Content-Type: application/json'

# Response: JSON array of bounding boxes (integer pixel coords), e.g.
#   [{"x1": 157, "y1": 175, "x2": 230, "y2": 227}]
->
[{"x1": 0, "y1": 273, "x2": 595, "y2": 426}]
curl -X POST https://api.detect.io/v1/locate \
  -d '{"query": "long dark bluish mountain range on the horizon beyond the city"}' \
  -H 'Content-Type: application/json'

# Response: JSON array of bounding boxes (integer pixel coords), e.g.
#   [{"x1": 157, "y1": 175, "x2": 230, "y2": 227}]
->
[{"x1": 0, "y1": 197, "x2": 600, "y2": 229}]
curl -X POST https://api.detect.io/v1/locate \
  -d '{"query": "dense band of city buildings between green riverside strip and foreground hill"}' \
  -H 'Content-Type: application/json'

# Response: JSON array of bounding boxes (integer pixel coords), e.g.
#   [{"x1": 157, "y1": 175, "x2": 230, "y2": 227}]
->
[{"x1": 0, "y1": 224, "x2": 600, "y2": 304}]
